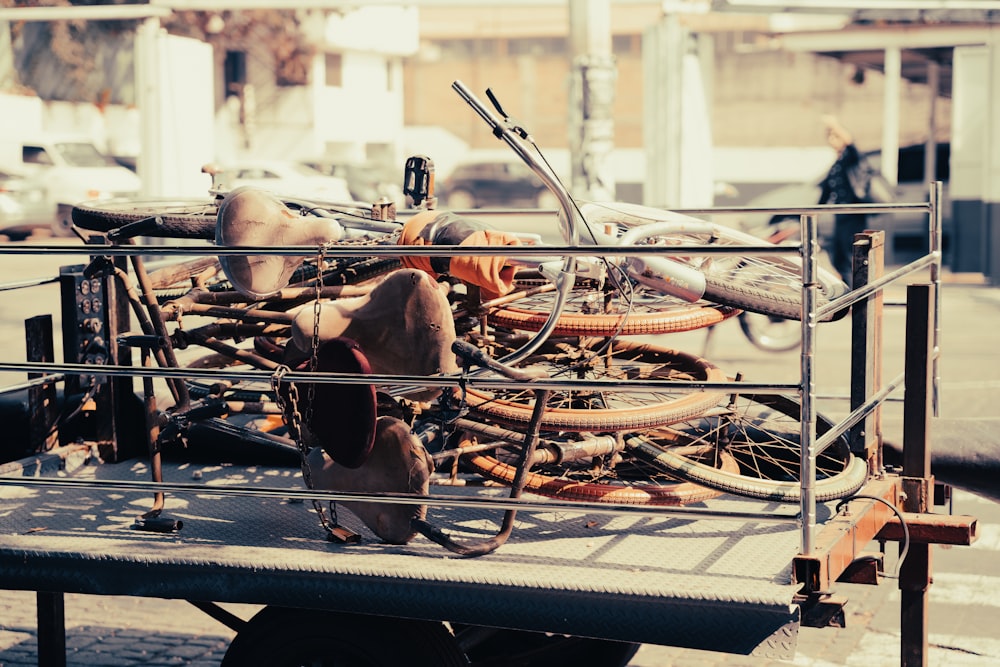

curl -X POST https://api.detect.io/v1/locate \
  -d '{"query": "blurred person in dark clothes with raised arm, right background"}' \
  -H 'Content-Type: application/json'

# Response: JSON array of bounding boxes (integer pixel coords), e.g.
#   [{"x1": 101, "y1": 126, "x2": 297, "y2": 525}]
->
[{"x1": 819, "y1": 116, "x2": 868, "y2": 286}]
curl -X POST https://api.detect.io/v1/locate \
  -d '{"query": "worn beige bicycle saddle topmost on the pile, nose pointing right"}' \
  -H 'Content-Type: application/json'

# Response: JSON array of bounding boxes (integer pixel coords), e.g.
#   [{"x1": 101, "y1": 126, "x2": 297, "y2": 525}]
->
[{"x1": 215, "y1": 186, "x2": 343, "y2": 300}]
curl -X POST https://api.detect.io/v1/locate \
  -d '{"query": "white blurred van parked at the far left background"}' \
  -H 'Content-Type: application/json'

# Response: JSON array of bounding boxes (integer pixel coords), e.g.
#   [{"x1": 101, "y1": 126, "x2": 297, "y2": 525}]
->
[{"x1": 8, "y1": 136, "x2": 142, "y2": 236}]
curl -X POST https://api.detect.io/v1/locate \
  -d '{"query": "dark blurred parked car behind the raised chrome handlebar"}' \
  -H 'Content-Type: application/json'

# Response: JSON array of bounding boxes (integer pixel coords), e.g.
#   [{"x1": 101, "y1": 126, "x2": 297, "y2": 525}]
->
[{"x1": 437, "y1": 160, "x2": 559, "y2": 209}]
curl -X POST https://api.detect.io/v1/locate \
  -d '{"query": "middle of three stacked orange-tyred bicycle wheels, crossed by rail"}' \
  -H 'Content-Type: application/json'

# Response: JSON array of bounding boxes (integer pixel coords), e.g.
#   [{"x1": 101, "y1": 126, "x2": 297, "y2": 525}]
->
[{"x1": 466, "y1": 340, "x2": 726, "y2": 433}]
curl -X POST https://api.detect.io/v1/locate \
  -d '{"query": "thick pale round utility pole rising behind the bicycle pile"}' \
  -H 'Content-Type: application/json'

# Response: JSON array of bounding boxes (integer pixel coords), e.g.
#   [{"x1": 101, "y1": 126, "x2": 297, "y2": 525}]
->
[{"x1": 568, "y1": 0, "x2": 617, "y2": 201}]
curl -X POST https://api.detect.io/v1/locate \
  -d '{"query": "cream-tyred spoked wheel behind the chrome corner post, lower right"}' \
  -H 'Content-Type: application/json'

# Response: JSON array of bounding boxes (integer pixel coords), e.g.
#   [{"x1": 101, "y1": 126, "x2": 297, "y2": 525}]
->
[{"x1": 629, "y1": 395, "x2": 868, "y2": 503}]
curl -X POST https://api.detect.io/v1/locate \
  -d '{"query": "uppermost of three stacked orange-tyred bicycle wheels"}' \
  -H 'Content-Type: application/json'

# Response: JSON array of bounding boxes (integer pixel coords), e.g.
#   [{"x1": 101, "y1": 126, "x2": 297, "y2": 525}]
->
[{"x1": 488, "y1": 278, "x2": 739, "y2": 336}]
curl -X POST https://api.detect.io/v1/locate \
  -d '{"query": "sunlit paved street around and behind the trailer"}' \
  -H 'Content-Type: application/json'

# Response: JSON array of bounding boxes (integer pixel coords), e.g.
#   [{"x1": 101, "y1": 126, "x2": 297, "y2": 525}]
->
[{"x1": 0, "y1": 237, "x2": 1000, "y2": 667}]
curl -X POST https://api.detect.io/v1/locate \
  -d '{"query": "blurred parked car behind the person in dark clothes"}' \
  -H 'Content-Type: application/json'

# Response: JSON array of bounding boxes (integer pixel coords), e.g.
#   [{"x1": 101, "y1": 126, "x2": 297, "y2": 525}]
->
[{"x1": 743, "y1": 143, "x2": 952, "y2": 265}]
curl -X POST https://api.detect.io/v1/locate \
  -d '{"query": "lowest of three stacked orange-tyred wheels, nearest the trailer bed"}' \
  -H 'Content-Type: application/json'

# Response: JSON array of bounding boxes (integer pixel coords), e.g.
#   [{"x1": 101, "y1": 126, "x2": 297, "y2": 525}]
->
[{"x1": 457, "y1": 422, "x2": 739, "y2": 505}]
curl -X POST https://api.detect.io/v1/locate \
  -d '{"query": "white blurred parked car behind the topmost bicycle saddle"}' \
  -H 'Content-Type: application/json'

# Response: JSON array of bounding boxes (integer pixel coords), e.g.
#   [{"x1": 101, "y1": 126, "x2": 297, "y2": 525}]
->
[{"x1": 216, "y1": 160, "x2": 353, "y2": 203}]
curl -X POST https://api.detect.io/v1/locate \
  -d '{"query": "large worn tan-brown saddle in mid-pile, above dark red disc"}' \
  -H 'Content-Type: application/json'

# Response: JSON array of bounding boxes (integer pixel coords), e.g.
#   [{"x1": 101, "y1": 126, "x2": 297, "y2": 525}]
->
[{"x1": 285, "y1": 269, "x2": 459, "y2": 400}]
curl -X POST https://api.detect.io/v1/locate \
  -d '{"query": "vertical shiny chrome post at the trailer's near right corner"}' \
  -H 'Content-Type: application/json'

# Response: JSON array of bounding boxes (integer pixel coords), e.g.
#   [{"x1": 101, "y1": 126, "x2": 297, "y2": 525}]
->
[{"x1": 799, "y1": 214, "x2": 819, "y2": 556}]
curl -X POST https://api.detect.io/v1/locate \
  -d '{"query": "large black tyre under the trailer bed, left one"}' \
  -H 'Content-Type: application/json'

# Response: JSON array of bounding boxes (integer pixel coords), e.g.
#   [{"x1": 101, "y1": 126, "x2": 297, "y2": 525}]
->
[{"x1": 222, "y1": 607, "x2": 469, "y2": 667}]
